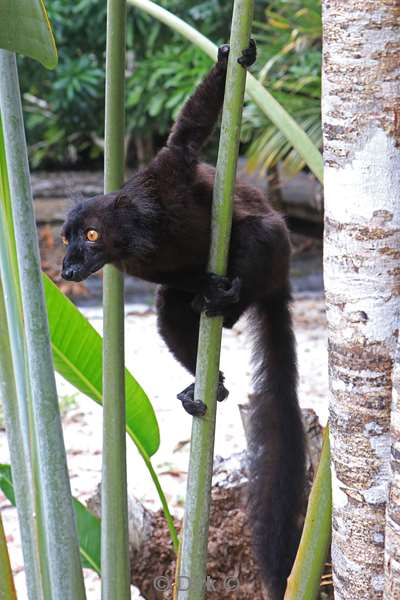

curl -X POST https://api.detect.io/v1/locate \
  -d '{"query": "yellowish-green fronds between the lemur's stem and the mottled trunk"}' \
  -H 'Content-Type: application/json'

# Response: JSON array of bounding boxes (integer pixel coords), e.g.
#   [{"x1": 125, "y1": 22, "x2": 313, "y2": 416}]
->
[{"x1": 243, "y1": 0, "x2": 322, "y2": 175}]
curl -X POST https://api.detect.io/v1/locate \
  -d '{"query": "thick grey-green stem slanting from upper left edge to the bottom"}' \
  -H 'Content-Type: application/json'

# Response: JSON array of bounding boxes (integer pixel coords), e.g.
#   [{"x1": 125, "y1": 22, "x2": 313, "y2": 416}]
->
[{"x1": 0, "y1": 50, "x2": 85, "y2": 600}]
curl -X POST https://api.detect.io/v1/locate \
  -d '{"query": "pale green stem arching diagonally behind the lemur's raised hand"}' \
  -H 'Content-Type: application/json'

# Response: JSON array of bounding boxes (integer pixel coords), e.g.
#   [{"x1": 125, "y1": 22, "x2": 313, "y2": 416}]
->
[{"x1": 127, "y1": 0, "x2": 323, "y2": 182}]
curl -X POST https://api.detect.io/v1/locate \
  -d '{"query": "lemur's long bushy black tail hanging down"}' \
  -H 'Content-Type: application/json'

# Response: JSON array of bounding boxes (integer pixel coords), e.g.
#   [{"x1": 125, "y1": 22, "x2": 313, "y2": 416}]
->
[{"x1": 249, "y1": 291, "x2": 305, "y2": 600}]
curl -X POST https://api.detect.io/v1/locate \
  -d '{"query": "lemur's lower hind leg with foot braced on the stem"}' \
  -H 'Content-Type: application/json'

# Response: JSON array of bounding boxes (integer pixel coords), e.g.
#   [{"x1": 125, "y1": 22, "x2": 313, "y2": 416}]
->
[{"x1": 157, "y1": 286, "x2": 228, "y2": 416}]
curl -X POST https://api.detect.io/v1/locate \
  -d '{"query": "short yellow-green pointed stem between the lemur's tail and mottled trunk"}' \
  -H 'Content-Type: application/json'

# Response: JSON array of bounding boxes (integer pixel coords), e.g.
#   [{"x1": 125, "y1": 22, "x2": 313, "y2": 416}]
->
[{"x1": 285, "y1": 427, "x2": 332, "y2": 600}]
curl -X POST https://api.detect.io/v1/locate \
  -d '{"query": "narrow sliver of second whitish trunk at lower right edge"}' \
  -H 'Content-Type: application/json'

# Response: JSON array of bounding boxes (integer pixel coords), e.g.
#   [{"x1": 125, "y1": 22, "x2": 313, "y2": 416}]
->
[{"x1": 384, "y1": 346, "x2": 400, "y2": 600}]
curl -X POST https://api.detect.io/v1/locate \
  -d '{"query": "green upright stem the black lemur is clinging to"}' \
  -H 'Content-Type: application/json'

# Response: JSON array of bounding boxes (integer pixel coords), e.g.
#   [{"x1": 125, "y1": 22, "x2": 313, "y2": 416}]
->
[{"x1": 177, "y1": 0, "x2": 253, "y2": 600}]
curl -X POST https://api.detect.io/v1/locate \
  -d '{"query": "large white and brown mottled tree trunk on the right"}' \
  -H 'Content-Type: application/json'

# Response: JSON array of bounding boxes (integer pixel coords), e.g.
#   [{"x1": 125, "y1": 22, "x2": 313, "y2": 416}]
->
[{"x1": 323, "y1": 0, "x2": 400, "y2": 600}]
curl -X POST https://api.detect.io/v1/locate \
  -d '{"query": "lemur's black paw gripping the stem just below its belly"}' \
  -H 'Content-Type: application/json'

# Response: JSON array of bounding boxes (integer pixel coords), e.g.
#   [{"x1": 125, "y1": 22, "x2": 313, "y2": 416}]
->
[{"x1": 192, "y1": 273, "x2": 241, "y2": 317}]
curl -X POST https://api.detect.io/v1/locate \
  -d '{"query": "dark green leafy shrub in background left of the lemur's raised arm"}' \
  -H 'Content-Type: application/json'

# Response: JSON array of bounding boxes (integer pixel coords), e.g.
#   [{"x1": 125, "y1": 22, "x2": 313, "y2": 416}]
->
[{"x1": 20, "y1": 0, "x2": 231, "y2": 168}]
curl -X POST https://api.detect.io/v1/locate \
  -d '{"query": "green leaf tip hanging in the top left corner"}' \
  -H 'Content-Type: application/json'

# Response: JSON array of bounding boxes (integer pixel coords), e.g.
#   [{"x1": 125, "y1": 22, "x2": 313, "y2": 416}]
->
[{"x1": 0, "y1": 0, "x2": 58, "y2": 69}]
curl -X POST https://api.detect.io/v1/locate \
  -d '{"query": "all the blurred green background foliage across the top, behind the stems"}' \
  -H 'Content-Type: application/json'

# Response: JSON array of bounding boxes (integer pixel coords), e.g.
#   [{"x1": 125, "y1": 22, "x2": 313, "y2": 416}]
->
[{"x1": 20, "y1": 0, "x2": 321, "y2": 168}]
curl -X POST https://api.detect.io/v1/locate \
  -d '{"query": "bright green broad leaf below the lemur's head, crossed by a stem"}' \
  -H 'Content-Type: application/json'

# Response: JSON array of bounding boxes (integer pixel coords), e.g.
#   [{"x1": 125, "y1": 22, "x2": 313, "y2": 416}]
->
[{"x1": 43, "y1": 275, "x2": 160, "y2": 456}]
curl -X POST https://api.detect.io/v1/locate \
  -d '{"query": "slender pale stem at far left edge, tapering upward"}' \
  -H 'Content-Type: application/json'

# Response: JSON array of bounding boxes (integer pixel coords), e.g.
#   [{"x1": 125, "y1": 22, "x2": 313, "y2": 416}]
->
[{"x1": 0, "y1": 117, "x2": 50, "y2": 600}]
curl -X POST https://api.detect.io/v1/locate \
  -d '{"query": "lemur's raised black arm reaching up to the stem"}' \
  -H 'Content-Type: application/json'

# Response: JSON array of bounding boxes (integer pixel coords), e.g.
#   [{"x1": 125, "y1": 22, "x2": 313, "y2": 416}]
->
[{"x1": 167, "y1": 45, "x2": 229, "y2": 160}]
